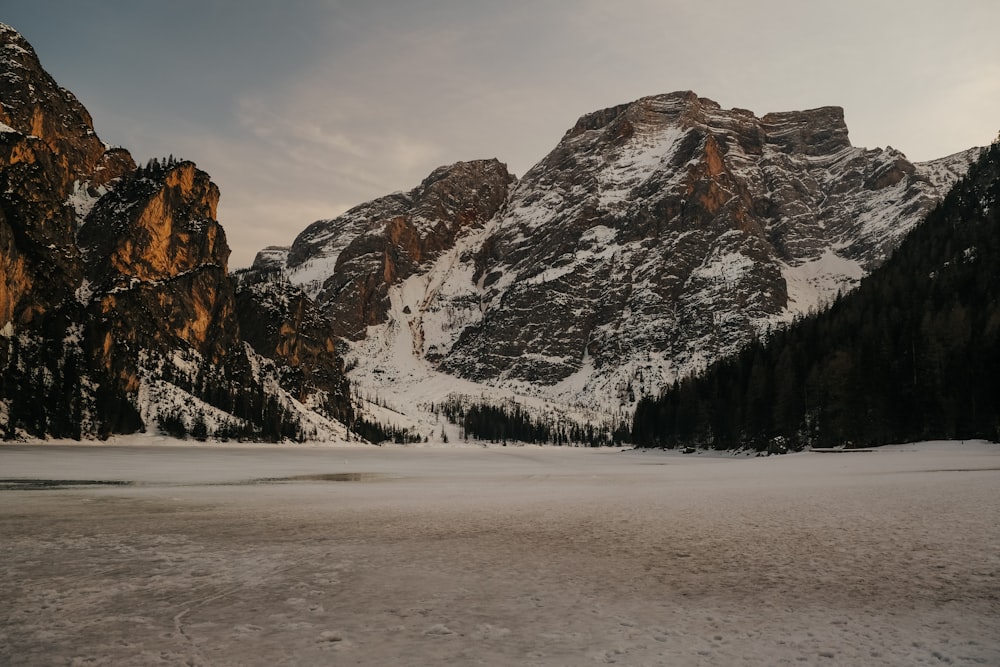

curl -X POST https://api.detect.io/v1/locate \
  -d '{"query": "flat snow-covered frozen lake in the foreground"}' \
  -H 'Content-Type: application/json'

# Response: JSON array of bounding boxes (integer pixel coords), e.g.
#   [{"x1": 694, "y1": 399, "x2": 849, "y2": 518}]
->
[{"x1": 0, "y1": 437, "x2": 1000, "y2": 665}]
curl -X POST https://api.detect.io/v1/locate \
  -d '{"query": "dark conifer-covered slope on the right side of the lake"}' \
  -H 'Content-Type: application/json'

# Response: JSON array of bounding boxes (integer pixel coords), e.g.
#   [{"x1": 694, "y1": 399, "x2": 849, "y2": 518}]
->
[{"x1": 634, "y1": 144, "x2": 1000, "y2": 451}]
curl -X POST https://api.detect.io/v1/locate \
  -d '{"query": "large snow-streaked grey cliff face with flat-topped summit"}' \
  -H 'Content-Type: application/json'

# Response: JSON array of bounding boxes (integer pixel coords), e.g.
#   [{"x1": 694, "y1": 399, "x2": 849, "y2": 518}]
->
[{"x1": 434, "y1": 92, "x2": 972, "y2": 398}]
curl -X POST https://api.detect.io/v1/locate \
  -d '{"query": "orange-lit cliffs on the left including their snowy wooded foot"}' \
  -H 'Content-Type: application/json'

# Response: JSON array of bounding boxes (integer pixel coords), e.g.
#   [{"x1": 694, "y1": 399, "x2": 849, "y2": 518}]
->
[{"x1": 0, "y1": 25, "x2": 350, "y2": 439}]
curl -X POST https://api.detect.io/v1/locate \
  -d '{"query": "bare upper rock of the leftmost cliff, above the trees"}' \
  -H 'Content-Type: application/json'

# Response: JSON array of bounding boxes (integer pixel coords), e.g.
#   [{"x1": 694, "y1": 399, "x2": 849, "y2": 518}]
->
[{"x1": 0, "y1": 24, "x2": 135, "y2": 334}]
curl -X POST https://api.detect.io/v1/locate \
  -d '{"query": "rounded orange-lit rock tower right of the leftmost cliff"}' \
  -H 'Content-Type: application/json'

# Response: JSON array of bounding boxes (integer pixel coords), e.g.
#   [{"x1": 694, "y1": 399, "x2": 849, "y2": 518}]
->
[{"x1": 77, "y1": 162, "x2": 242, "y2": 392}]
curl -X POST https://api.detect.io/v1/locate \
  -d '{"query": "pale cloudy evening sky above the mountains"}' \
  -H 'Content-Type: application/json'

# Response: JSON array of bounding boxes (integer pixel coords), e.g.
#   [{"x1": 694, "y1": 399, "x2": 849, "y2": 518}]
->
[{"x1": 0, "y1": 0, "x2": 1000, "y2": 268}]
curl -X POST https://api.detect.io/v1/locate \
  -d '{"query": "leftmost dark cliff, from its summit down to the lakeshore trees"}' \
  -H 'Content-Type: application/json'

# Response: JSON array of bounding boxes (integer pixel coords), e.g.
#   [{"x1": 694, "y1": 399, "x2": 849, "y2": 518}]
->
[{"x1": 0, "y1": 25, "x2": 139, "y2": 437}]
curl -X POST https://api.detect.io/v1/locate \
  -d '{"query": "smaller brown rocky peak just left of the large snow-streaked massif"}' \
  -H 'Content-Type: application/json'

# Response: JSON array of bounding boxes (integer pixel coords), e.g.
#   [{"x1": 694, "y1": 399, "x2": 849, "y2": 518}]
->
[{"x1": 286, "y1": 160, "x2": 514, "y2": 339}]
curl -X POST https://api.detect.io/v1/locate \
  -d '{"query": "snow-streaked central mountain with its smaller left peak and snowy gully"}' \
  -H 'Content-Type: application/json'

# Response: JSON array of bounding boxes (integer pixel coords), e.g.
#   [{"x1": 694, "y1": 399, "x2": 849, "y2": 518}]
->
[{"x1": 258, "y1": 92, "x2": 977, "y2": 436}]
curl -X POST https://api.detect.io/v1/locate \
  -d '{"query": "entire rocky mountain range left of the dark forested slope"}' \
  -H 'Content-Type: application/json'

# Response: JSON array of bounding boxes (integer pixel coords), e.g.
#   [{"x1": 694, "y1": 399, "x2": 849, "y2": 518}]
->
[{"x1": 0, "y1": 26, "x2": 978, "y2": 440}]
